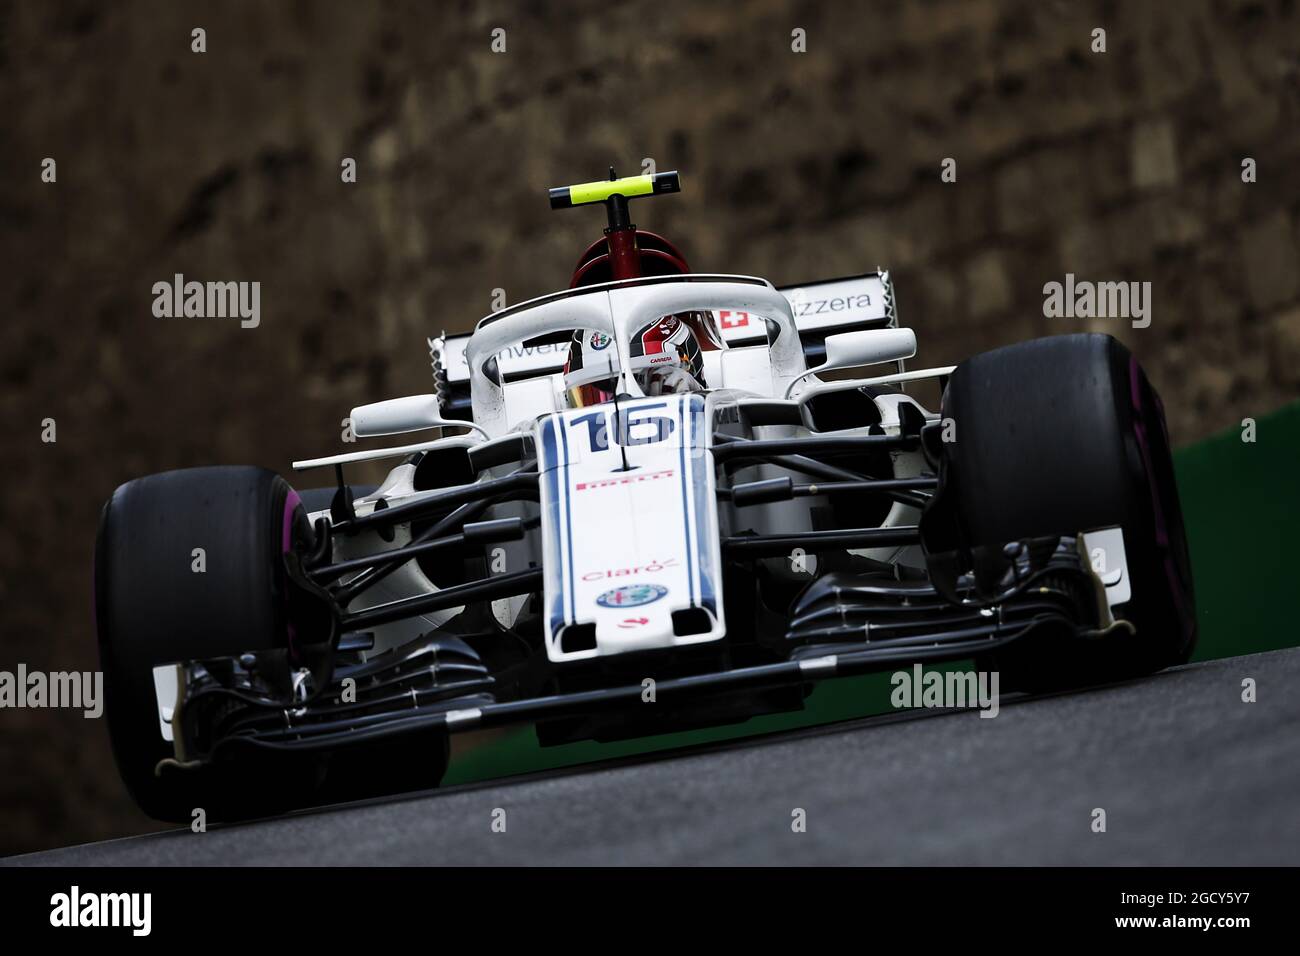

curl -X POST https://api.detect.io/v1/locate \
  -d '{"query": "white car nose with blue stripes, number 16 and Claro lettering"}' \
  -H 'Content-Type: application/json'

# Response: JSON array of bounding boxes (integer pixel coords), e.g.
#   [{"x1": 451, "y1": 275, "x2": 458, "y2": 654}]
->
[{"x1": 538, "y1": 395, "x2": 725, "y2": 662}]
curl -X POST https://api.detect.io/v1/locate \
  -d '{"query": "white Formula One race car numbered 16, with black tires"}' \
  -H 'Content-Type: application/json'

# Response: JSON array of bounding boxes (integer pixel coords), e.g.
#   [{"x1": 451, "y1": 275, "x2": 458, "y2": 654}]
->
[{"x1": 95, "y1": 170, "x2": 1196, "y2": 821}]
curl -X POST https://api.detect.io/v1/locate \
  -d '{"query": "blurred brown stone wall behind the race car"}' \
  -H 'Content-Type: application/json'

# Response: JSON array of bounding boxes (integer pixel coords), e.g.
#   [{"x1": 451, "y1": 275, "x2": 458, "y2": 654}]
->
[{"x1": 0, "y1": 0, "x2": 1300, "y2": 853}]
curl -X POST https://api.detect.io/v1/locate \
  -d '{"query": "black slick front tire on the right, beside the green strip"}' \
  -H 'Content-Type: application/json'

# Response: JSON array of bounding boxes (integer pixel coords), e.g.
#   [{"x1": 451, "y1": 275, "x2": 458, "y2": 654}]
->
[{"x1": 941, "y1": 334, "x2": 1196, "y2": 691}]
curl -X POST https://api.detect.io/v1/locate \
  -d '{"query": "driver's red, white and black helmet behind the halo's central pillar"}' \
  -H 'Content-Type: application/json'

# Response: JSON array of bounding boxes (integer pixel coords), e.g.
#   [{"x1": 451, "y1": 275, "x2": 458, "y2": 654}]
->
[{"x1": 564, "y1": 315, "x2": 706, "y2": 408}]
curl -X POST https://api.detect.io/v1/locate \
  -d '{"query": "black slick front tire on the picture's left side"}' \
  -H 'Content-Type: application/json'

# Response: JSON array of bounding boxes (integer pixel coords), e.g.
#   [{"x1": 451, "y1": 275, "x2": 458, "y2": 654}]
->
[{"x1": 95, "y1": 467, "x2": 320, "y2": 822}]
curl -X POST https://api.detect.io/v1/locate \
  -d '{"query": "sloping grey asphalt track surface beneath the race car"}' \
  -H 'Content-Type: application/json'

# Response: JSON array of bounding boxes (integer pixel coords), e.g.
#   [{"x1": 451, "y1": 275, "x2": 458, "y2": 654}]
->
[{"x1": 10, "y1": 649, "x2": 1300, "y2": 866}]
